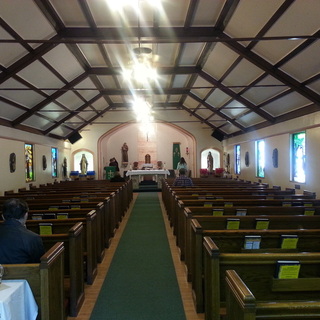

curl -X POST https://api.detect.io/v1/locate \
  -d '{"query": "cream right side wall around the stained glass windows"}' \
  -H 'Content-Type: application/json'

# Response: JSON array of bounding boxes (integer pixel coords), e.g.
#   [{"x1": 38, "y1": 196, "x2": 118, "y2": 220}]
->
[{"x1": 224, "y1": 113, "x2": 320, "y2": 196}]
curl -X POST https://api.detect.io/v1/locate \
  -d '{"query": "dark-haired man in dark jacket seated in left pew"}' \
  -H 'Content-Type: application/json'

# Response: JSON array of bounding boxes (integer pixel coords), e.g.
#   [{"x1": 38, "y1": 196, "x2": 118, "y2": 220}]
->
[{"x1": 0, "y1": 198, "x2": 45, "y2": 264}]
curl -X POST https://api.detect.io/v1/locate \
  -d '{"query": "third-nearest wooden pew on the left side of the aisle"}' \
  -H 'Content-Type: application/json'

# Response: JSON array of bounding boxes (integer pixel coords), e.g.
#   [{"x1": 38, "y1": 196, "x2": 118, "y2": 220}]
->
[{"x1": 26, "y1": 210, "x2": 98, "y2": 284}]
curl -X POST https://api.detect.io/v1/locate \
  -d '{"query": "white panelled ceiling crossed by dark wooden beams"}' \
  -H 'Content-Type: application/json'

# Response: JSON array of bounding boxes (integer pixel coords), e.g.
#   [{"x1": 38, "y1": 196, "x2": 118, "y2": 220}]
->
[{"x1": 0, "y1": 0, "x2": 320, "y2": 140}]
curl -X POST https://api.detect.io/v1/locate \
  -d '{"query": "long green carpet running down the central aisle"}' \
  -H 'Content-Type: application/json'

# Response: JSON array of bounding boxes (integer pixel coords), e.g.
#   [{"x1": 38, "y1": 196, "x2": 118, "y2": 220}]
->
[{"x1": 90, "y1": 192, "x2": 186, "y2": 320}]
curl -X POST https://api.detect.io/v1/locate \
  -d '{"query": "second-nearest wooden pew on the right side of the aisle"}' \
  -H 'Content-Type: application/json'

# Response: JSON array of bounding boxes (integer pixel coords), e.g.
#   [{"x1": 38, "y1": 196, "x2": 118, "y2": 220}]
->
[{"x1": 203, "y1": 236, "x2": 320, "y2": 320}]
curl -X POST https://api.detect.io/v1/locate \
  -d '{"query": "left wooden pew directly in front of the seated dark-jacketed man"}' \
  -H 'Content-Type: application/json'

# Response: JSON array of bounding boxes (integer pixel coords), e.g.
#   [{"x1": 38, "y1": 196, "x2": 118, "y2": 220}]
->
[{"x1": 28, "y1": 222, "x2": 85, "y2": 317}]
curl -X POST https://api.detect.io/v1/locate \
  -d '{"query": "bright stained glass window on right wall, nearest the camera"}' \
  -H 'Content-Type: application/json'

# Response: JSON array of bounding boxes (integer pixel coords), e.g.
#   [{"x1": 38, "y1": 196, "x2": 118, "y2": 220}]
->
[{"x1": 291, "y1": 132, "x2": 306, "y2": 183}]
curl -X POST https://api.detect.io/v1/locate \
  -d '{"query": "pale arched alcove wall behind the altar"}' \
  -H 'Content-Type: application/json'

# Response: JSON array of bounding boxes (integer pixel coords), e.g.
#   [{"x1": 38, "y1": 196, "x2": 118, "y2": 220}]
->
[{"x1": 98, "y1": 123, "x2": 196, "y2": 179}]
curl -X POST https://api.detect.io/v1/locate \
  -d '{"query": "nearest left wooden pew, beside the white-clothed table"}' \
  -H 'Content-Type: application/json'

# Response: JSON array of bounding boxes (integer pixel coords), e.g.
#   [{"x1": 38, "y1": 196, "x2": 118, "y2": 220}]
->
[{"x1": 3, "y1": 242, "x2": 66, "y2": 320}]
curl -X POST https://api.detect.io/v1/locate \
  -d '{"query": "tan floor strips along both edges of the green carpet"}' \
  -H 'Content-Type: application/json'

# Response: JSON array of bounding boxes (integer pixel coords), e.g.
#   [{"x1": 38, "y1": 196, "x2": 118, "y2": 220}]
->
[{"x1": 68, "y1": 193, "x2": 204, "y2": 320}]
